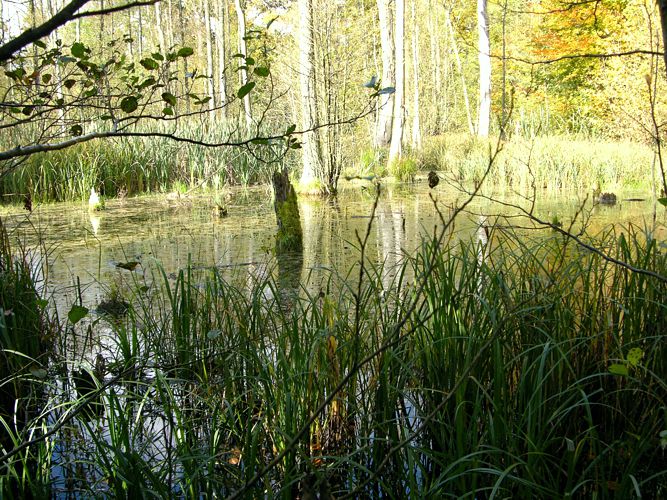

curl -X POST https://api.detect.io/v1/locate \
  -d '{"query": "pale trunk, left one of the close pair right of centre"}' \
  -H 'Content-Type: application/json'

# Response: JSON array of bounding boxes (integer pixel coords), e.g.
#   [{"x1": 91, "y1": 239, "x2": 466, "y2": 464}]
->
[{"x1": 375, "y1": 0, "x2": 396, "y2": 147}]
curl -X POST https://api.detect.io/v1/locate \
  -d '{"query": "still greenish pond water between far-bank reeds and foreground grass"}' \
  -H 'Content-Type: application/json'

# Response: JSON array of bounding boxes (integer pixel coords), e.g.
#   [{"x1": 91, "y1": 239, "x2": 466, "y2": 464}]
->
[{"x1": 0, "y1": 181, "x2": 665, "y2": 309}]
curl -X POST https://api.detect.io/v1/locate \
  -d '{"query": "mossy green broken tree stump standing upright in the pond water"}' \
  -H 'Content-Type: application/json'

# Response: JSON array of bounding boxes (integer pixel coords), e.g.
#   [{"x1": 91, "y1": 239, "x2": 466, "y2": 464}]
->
[{"x1": 273, "y1": 169, "x2": 303, "y2": 254}]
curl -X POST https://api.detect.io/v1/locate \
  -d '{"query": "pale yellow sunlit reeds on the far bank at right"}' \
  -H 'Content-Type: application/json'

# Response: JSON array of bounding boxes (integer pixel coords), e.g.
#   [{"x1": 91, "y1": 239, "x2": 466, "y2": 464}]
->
[{"x1": 419, "y1": 134, "x2": 660, "y2": 192}]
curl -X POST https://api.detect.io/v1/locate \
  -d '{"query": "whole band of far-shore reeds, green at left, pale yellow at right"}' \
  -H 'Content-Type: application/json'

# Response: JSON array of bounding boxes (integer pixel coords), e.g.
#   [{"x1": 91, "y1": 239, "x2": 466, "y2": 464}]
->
[{"x1": 0, "y1": 132, "x2": 660, "y2": 204}]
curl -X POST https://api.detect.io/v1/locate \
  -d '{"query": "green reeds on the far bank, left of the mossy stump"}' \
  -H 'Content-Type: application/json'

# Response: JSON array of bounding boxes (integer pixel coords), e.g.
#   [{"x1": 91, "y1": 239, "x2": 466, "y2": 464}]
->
[{"x1": 0, "y1": 121, "x2": 292, "y2": 203}]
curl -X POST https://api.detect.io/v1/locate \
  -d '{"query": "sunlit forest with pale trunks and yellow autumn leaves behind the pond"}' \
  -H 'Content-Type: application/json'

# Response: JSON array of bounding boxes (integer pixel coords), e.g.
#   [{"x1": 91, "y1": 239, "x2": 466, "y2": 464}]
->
[{"x1": 0, "y1": 0, "x2": 665, "y2": 199}]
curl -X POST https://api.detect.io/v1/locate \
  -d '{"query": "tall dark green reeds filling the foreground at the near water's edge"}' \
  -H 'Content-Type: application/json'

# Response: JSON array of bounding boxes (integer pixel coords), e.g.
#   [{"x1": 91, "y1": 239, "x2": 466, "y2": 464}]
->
[{"x1": 0, "y1": 221, "x2": 667, "y2": 498}]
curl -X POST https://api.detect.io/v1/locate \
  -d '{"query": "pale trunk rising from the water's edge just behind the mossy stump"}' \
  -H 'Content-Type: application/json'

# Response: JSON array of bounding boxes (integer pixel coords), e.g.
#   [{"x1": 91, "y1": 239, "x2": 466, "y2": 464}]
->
[{"x1": 298, "y1": 0, "x2": 321, "y2": 189}]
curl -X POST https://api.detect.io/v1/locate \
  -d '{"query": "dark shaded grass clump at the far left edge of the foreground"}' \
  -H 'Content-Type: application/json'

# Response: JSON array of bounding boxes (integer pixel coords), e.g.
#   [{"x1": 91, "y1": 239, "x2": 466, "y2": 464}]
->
[{"x1": 0, "y1": 220, "x2": 55, "y2": 498}]
